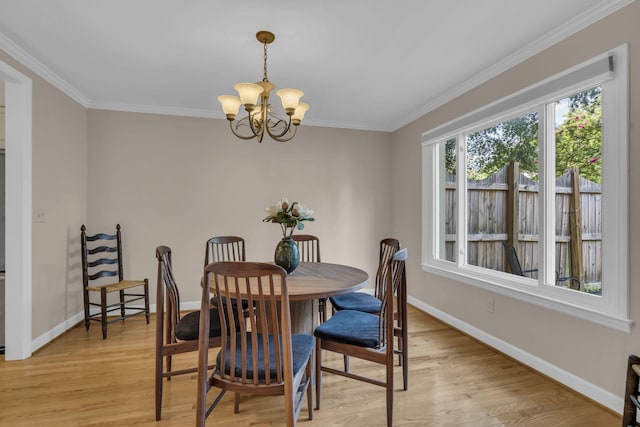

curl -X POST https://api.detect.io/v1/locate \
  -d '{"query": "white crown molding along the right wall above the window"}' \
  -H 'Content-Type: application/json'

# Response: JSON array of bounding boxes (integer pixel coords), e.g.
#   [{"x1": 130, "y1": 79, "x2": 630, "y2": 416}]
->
[{"x1": 392, "y1": 0, "x2": 636, "y2": 131}]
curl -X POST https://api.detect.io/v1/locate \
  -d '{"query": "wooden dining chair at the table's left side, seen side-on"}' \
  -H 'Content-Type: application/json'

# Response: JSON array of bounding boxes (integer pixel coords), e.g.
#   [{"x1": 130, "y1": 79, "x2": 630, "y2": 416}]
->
[{"x1": 155, "y1": 246, "x2": 230, "y2": 420}]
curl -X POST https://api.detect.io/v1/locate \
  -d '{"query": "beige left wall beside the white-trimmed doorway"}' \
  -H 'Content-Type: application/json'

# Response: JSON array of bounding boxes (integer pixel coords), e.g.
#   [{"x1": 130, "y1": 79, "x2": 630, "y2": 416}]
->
[{"x1": 0, "y1": 51, "x2": 87, "y2": 339}]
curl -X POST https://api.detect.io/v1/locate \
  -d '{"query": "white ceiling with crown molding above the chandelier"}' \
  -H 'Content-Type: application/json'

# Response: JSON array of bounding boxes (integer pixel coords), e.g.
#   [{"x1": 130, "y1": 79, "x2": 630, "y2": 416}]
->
[{"x1": 0, "y1": 0, "x2": 633, "y2": 131}]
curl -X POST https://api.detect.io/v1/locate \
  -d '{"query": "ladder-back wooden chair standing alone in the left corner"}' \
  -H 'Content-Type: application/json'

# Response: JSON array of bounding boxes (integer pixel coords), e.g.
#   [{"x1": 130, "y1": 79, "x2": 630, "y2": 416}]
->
[{"x1": 80, "y1": 224, "x2": 149, "y2": 339}]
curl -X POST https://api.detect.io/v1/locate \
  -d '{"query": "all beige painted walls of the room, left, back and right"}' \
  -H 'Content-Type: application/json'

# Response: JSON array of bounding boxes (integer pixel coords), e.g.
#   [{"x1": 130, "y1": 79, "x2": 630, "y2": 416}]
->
[{"x1": 0, "y1": 2, "x2": 640, "y2": 408}]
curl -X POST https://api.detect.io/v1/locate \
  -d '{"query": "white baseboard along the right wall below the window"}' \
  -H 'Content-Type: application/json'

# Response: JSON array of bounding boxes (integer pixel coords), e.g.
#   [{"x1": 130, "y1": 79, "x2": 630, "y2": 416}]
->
[{"x1": 407, "y1": 296, "x2": 624, "y2": 414}]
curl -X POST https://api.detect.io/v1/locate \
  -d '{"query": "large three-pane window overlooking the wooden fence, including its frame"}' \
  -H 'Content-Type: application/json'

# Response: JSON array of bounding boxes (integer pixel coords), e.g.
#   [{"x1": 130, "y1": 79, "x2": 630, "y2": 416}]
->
[{"x1": 422, "y1": 45, "x2": 630, "y2": 332}]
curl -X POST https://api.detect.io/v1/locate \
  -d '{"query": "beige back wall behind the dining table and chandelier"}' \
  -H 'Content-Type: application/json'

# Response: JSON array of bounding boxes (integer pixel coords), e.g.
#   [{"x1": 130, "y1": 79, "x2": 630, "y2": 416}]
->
[{"x1": 88, "y1": 110, "x2": 391, "y2": 302}]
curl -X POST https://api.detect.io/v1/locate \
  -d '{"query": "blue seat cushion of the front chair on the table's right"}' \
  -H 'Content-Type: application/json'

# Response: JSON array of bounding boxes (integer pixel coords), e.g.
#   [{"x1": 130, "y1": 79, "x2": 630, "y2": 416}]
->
[{"x1": 313, "y1": 310, "x2": 380, "y2": 348}]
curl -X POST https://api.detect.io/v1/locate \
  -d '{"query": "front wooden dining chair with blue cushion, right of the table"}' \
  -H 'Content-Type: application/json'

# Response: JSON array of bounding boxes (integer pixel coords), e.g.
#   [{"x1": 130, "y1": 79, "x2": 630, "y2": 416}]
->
[{"x1": 314, "y1": 249, "x2": 407, "y2": 427}]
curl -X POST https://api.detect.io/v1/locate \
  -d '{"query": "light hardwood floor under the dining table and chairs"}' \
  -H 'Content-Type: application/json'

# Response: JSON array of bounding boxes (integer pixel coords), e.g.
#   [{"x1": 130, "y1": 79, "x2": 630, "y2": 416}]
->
[{"x1": 0, "y1": 308, "x2": 623, "y2": 427}]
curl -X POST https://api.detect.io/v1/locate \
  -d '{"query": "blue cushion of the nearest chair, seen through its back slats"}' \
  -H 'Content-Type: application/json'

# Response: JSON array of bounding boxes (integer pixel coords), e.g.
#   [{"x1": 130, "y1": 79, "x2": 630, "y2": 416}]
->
[{"x1": 216, "y1": 333, "x2": 315, "y2": 380}]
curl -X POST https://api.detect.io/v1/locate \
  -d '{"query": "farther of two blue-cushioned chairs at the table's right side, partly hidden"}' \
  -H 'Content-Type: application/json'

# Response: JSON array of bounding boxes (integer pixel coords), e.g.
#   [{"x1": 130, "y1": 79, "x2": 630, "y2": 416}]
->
[{"x1": 330, "y1": 238, "x2": 409, "y2": 390}]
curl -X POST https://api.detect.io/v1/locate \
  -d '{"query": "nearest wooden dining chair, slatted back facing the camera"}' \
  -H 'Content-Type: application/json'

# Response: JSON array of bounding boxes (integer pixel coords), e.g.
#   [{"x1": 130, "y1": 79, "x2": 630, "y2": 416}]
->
[{"x1": 196, "y1": 262, "x2": 314, "y2": 426}]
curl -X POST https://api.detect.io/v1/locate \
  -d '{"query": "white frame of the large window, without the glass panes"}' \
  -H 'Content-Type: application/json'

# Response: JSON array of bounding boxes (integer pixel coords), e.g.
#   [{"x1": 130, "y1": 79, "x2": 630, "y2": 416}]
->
[{"x1": 422, "y1": 44, "x2": 632, "y2": 333}]
